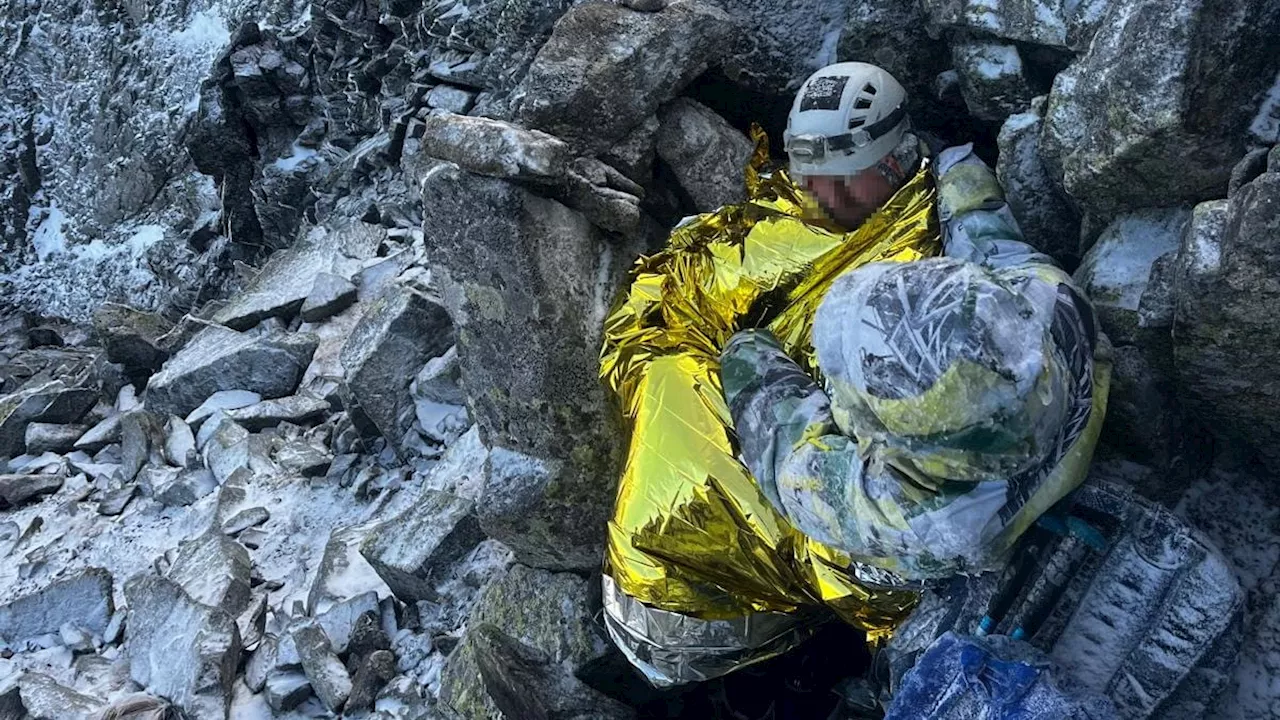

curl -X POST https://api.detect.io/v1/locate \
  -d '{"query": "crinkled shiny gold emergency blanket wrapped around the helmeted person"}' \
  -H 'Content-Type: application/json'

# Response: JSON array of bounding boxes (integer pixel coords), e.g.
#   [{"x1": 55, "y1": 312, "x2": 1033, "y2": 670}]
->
[{"x1": 600, "y1": 128, "x2": 940, "y2": 660}]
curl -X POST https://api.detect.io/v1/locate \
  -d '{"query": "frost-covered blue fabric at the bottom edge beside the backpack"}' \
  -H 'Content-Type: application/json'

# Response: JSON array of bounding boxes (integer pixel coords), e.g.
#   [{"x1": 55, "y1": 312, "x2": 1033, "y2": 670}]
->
[{"x1": 884, "y1": 633, "x2": 1117, "y2": 720}]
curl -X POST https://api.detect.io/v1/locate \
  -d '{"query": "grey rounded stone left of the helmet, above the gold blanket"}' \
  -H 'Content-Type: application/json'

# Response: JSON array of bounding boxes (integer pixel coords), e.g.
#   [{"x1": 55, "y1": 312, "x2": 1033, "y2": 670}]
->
[{"x1": 657, "y1": 97, "x2": 754, "y2": 213}]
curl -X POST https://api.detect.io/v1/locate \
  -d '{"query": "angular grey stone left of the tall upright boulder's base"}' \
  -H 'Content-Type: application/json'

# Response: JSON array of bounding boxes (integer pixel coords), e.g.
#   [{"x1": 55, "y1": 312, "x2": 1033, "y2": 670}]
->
[{"x1": 360, "y1": 491, "x2": 484, "y2": 602}]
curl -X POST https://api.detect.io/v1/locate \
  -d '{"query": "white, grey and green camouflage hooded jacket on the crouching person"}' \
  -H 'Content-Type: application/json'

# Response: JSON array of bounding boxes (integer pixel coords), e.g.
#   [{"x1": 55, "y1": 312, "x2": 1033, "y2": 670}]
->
[{"x1": 722, "y1": 145, "x2": 1106, "y2": 580}]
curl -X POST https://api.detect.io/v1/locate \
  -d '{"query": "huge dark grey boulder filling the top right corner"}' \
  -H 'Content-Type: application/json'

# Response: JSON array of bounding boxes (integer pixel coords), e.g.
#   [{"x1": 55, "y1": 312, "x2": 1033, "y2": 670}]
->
[{"x1": 1041, "y1": 0, "x2": 1280, "y2": 218}]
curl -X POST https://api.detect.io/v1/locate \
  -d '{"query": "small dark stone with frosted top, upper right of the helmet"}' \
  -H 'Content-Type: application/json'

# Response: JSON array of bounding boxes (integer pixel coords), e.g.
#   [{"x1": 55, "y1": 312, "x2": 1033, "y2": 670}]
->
[{"x1": 951, "y1": 41, "x2": 1034, "y2": 122}]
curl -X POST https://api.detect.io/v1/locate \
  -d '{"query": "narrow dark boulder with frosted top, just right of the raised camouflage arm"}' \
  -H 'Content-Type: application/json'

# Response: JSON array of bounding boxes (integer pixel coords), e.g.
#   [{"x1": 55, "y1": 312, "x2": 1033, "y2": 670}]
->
[{"x1": 996, "y1": 97, "x2": 1080, "y2": 266}]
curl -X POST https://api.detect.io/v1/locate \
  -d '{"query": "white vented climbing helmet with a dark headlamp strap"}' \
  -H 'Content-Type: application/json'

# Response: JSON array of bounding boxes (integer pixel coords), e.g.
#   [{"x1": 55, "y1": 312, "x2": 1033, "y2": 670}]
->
[{"x1": 782, "y1": 63, "x2": 906, "y2": 179}]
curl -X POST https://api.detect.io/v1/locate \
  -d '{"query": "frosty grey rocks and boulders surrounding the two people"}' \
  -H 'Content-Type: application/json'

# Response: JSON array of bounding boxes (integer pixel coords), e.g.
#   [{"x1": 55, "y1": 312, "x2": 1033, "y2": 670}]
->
[{"x1": 0, "y1": 0, "x2": 1280, "y2": 719}]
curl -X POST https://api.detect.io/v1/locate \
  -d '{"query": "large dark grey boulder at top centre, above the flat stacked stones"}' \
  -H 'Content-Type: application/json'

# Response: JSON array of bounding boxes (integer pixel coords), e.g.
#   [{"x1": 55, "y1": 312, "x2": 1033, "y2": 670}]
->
[{"x1": 517, "y1": 0, "x2": 730, "y2": 152}]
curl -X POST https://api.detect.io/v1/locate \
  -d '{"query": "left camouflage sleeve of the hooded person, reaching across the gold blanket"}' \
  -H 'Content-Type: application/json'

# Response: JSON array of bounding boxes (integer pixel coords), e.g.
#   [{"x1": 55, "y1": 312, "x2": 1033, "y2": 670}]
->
[{"x1": 722, "y1": 331, "x2": 1005, "y2": 578}]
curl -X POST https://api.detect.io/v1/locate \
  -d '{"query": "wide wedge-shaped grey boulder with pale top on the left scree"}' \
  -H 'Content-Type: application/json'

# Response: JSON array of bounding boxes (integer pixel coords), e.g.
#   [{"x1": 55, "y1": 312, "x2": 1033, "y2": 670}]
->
[{"x1": 146, "y1": 325, "x2": 319, "y2": 418}]
